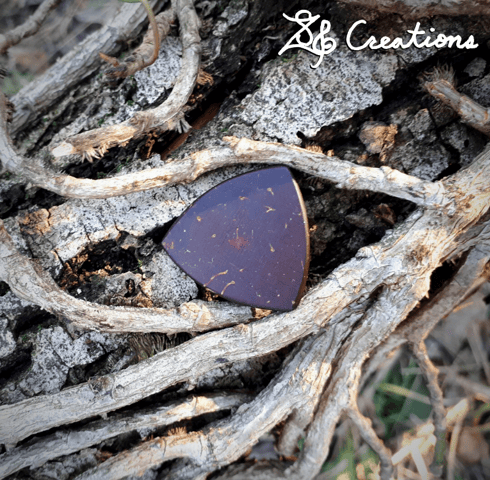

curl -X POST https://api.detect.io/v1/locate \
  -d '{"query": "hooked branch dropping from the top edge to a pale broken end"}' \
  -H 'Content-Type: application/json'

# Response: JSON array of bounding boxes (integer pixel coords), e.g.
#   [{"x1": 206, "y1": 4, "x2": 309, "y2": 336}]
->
[{"x1": 53, "y1": 0, "x2": 201, "y2": 158}]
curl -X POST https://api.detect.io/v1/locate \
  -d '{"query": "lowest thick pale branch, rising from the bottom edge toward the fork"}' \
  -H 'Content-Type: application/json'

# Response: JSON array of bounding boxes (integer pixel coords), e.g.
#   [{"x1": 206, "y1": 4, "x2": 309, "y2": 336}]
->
[{"x1": 74, "y1": 330, "x2": 339, "y2": 480}]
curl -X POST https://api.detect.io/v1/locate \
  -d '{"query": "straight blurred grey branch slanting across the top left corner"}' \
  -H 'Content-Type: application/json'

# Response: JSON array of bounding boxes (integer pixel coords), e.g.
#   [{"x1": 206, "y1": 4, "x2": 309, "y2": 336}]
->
[{"x1": 8, "y1": 0, "x2": 164, "y2": 136}]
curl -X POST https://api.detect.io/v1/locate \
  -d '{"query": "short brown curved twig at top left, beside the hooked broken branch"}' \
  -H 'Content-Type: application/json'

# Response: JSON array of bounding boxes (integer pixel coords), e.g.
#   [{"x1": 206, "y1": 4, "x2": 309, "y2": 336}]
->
[{"x1": 100, "y1": 8, "x2": 175, "y2": 78}]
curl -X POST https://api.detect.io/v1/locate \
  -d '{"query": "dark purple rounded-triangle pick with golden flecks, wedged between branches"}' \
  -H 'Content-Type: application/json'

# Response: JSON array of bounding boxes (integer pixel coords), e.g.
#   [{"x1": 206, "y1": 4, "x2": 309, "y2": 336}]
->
[{"x1": 163, "y1": 167, "x2": 309, "y2": 310}]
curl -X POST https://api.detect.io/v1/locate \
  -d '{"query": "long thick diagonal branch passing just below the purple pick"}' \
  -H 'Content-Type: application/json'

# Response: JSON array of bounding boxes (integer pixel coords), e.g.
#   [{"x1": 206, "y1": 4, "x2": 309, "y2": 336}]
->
[{"x1": 0, "y1": 142, "x2": 490, "y2": 444}]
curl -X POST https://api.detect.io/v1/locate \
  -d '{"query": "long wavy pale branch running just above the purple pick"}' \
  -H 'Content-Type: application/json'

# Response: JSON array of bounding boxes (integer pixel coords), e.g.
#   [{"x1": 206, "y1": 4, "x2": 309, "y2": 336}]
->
[{"x1": 0, "y1": 126, "x2": 448, "y2": 203}]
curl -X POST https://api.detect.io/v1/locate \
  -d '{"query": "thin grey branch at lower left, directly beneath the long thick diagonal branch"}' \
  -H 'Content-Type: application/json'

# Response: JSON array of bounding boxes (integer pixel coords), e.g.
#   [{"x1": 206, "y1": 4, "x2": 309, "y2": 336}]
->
[{"x1": 0, "y1": 394, "x2": 252, "y2": 478}]
